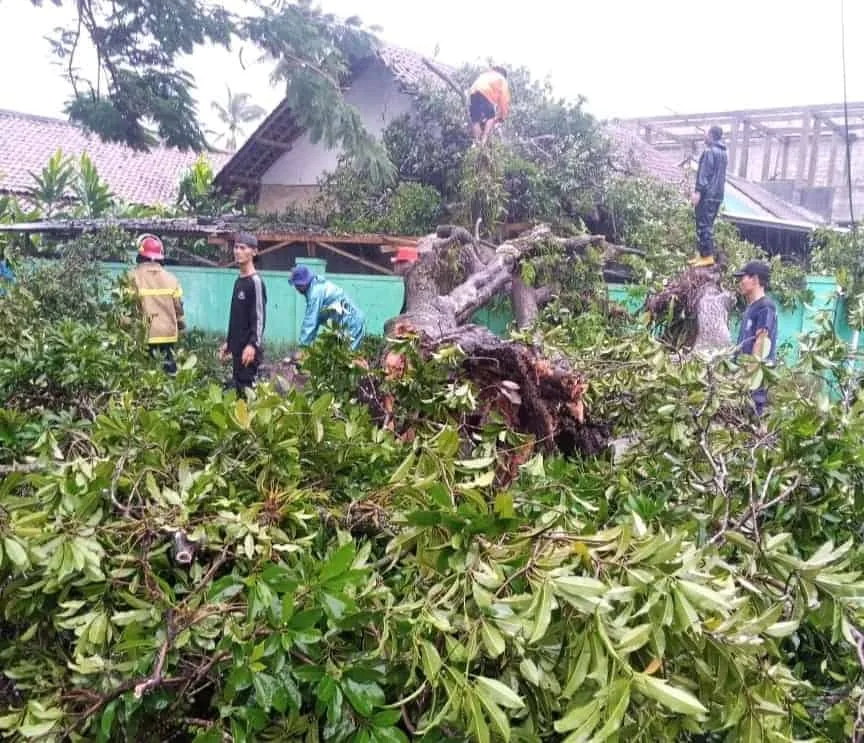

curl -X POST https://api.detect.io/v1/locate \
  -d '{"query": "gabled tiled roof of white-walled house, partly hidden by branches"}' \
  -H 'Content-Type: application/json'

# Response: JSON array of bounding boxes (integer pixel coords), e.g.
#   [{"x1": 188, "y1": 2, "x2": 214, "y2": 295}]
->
[{"x1": 216, "y1": 44, "x2": 453, "y2": 195}]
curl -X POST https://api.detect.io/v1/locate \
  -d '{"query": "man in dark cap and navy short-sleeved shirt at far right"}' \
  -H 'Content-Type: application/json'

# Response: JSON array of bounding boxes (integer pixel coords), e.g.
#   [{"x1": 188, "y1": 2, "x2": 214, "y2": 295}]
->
[{"x1": 734, "y1": 261, "x2": 777, "y2": 415}]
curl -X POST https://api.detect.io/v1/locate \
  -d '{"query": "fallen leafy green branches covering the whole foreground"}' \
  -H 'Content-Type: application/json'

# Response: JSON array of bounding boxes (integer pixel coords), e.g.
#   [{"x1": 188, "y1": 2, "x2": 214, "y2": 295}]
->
[{"x1": 0, "y1": 237, "x2": 864, "y2": 743}]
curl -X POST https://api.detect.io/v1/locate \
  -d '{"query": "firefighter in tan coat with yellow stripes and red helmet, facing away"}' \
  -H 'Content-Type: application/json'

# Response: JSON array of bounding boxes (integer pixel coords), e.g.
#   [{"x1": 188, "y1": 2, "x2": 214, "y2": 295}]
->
[{"x1": 130, "y1": 234, "x2": 186, "y2": 374}]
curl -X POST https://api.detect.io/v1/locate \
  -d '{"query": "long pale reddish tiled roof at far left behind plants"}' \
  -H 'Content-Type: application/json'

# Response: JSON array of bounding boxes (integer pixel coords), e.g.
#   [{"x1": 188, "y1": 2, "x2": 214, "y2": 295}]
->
[{"x1": 0, "y1": 110, "x2": 230, "y2": 205}]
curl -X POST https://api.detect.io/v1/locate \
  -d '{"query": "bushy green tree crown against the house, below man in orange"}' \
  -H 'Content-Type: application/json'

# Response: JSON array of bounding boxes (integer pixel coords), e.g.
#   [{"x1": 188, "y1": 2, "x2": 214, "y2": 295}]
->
[{"x1": 296, "y1": 67, "x2": 609, "y2": 238}]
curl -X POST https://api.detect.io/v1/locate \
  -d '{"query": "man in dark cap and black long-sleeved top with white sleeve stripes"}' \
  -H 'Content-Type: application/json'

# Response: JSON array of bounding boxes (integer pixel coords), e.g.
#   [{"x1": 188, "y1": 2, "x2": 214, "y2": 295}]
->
[{"x1": 221, "y1": 232, "x2": 267, "y2": 397}]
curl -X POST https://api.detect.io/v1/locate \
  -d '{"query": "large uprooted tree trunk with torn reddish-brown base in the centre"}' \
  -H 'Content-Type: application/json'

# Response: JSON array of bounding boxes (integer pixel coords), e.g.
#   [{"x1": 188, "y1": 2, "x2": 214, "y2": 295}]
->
[{"x1": 385, "y1": 226, "x2": 636, "y2": 456}]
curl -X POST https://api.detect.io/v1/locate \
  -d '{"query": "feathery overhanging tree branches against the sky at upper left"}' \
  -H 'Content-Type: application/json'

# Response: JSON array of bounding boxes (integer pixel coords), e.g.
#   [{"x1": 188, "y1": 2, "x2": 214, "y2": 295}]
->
[{"x1": 38, "y1": 0, "x2": 389, "y2": 178}]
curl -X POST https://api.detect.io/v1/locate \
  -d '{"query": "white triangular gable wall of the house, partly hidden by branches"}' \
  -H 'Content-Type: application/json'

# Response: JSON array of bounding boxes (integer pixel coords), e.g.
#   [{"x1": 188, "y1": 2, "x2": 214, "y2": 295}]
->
[{"x1": 261, "y1": 60, "x2": 412, "y2": 186}]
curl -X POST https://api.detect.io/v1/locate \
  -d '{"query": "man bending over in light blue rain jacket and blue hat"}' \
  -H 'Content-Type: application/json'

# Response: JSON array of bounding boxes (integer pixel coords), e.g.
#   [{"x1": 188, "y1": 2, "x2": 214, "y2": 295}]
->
[{"x1": 291, "y1": 266, "x2": 366, "y2": 350}]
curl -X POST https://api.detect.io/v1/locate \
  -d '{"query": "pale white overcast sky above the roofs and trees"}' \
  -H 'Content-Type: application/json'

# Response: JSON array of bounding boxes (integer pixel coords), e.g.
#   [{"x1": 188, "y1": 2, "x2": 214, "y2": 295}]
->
[{"x1": 0, "y1": 0, "x2": 864, "y2": 140}]
